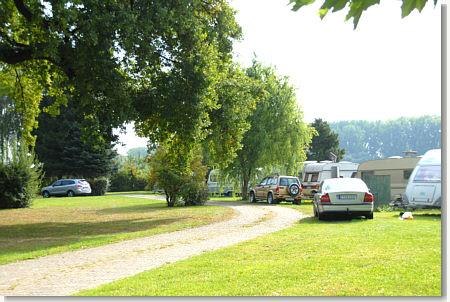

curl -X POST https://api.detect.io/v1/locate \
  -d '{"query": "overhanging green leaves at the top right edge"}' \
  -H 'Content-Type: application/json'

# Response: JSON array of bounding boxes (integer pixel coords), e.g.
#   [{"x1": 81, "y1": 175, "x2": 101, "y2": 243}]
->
[{"x1": 289, "y1": 0, "x2": 437, "y2": 28}]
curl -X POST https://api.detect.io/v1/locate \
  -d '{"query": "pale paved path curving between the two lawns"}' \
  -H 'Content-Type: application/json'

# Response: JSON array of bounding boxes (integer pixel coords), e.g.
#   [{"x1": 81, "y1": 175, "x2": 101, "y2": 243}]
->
[{"x1": 0, "y1": 195, "x2": 302, "y2": 296}]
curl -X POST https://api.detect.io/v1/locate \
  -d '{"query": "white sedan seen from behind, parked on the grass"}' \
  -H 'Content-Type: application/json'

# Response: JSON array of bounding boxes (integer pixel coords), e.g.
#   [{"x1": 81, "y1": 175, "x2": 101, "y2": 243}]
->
[{"x1": 313, "y1": 178, "x2": 374, "y2": 220}]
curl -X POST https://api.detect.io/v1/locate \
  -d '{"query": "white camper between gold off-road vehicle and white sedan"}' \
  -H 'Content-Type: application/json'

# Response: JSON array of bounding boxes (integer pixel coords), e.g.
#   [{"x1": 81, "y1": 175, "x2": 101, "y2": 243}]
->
[{"x1": 302, "y1": 160, "x2": 358, "y2": 199}]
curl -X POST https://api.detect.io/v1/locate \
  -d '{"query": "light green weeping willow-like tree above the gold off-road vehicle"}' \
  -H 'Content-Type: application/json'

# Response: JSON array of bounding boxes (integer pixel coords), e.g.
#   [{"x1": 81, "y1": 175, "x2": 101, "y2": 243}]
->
[{"x1": 227, "y1": 61, "x2": 313, "y2": 198}]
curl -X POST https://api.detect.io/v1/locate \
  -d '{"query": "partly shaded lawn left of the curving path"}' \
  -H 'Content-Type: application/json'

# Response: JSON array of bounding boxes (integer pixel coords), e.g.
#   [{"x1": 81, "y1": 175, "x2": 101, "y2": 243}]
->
[{"x1": 0, "y1": 195, "x2": 233, "y2": 264}]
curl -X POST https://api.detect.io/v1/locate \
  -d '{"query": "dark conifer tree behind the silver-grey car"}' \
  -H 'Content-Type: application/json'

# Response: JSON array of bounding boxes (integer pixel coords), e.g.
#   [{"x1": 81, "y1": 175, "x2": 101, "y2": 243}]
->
[{"x1": 35, "y1": 100, "x2": 116, "y2": 178}]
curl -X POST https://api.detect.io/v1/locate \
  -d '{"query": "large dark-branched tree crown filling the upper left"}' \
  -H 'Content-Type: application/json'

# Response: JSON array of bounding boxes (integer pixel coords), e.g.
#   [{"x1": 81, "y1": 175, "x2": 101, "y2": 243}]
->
[{"x1": 0, "y1": 0, "x2": 240, "y2": 150}]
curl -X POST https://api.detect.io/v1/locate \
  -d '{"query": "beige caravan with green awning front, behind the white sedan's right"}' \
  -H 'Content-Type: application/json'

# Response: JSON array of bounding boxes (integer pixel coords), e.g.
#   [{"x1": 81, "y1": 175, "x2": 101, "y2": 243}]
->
[{"x1": 356, "y1": 156, "x2": 420, "y2": 200}]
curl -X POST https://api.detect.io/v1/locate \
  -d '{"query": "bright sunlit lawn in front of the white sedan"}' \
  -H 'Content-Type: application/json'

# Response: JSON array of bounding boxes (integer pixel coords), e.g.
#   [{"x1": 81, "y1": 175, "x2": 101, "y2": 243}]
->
[{"x1": 80, "y1": 203, "x2": 441, "y2": 296}]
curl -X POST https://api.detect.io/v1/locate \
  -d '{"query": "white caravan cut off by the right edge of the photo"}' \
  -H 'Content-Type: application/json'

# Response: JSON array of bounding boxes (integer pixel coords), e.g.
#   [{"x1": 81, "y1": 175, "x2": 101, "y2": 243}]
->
[{"x1": 403, "y1": 149, "x2": 442, "y2": 209}]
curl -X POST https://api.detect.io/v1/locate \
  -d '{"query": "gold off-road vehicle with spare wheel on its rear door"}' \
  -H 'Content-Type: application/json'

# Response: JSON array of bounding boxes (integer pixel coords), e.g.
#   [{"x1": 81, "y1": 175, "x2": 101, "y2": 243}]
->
[{"x1": 249, "y1": 175, "x2": 302, "y2": 204}]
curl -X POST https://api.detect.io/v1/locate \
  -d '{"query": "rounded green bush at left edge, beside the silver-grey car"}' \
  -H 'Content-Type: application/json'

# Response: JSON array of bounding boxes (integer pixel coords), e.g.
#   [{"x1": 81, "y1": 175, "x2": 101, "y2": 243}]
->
[{"x1": 0, "y1": 142, "x2": 42, "y2": 209}]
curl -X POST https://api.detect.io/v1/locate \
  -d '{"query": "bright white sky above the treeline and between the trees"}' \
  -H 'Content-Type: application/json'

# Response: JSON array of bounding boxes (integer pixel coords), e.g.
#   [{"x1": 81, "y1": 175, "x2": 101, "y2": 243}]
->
[{"x1": 117, "y1": 0, "x2": 441, "y2": 154}]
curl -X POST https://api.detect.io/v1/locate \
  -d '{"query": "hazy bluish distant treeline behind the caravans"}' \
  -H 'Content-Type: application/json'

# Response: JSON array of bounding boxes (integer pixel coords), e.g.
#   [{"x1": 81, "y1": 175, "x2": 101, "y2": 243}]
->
[{"x1": 330, "y1": 116, "x2": 441, "y2": 163}]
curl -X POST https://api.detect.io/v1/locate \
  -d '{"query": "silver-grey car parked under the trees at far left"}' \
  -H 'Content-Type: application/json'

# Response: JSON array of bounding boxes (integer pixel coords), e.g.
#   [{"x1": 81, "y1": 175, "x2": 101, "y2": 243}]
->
[{"x1": 41, "y1": 179, "x2": 92, "y2": 198}]
